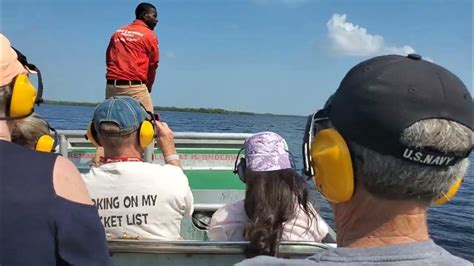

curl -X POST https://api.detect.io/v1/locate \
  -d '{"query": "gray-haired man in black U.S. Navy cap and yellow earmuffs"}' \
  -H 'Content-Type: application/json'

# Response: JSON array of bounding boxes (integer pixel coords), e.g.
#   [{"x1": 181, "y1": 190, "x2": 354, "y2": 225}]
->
[{"x1": 239, "y1": 54, "x2": 474, "y2": 265}]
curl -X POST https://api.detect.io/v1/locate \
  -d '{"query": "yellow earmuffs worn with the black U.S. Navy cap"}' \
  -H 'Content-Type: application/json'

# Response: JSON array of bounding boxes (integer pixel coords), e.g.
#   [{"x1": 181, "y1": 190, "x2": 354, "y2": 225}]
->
[{"x1": 303, "y1": 109, "x2": 463, "y2": 205}]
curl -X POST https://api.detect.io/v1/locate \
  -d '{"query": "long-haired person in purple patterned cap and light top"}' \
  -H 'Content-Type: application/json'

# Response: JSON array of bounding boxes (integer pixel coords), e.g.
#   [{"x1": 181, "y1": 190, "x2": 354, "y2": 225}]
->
[{"x1": 208, "y1": 132, "x2": 328, "y2": 257}]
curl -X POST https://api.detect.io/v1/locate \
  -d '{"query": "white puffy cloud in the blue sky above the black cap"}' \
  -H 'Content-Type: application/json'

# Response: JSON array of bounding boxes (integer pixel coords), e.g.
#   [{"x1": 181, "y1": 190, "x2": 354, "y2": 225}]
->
[{"x1": 326, "y1": 14, "x2": 415, "y2": 56}]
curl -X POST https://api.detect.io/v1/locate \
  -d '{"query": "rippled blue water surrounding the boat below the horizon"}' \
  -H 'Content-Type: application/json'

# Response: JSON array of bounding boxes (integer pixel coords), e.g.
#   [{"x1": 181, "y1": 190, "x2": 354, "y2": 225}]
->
[{"x1": 36, "y1": 105, "x2": 474, "y2": 261}]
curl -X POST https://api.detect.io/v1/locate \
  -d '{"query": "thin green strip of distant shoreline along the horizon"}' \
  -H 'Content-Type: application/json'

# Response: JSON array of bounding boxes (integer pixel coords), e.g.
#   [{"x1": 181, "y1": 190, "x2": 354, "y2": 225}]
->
[{"x1": 42, "y1": 99, "x2": 300, "y2": 117}]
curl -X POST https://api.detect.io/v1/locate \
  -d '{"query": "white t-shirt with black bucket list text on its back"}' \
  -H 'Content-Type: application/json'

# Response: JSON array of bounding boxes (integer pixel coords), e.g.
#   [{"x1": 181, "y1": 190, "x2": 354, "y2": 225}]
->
[{"x1": 83, "y1": 162, "x2": 194, "y2": 240}]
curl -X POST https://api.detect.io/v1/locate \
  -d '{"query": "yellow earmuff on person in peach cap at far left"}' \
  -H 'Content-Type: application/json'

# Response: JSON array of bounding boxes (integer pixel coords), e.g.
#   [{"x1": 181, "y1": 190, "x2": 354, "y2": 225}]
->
[{"x1": 0, "y1": 47, "x2": 43, "y2": 120}]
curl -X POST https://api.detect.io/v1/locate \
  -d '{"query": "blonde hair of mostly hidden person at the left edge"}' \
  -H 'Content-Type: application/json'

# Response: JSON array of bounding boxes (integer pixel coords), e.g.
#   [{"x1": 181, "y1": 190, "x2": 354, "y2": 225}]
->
[{"x1": 12, "y1": 113, "x2": 51, "y2": 149}]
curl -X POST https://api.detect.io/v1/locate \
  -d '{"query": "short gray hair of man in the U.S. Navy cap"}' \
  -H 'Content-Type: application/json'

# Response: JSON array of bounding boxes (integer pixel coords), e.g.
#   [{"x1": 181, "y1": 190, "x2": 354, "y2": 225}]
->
[{"x1": 349, "y1": 119, "x2": 473, "y2": 202}]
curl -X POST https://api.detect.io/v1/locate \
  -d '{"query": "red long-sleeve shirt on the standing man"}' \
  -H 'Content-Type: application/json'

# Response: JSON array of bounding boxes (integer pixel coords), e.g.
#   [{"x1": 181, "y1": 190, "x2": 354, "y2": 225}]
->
[{"x1": 106, "y1": 19, "x2": 160, "y2": 91}]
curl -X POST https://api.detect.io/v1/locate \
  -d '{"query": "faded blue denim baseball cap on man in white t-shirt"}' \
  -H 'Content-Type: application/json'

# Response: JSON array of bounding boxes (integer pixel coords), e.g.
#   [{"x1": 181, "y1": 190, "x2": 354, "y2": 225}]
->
[{"x1": 93, "y1": 96, "x2": 147, "y2": 135}]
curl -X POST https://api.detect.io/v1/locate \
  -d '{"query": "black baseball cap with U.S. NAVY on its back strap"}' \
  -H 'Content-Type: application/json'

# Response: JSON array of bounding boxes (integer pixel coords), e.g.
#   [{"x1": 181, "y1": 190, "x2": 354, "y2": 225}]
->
[{"x1": 326, "y1": 54, "x2": 474, "y2": 166}]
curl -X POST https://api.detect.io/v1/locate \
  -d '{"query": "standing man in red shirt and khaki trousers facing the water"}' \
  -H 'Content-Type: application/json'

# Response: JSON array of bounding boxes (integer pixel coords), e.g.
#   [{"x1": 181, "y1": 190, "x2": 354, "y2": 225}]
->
[{"x1": 105, "y1": 3, "x2": 159, "y2": 112}]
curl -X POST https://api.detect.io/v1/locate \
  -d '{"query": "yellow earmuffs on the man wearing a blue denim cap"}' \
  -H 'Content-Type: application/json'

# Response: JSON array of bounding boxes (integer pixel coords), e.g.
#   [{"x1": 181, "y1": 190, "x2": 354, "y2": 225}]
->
[{"x1": 84, "y1": 103, "x2": 156, "y2": 148}]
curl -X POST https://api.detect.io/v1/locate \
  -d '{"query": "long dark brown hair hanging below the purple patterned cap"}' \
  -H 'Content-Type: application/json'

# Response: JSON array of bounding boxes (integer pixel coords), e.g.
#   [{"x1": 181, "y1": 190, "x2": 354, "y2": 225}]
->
[{"x1": 244, "y1": 169, "x2": 315, "y2": 258}]
